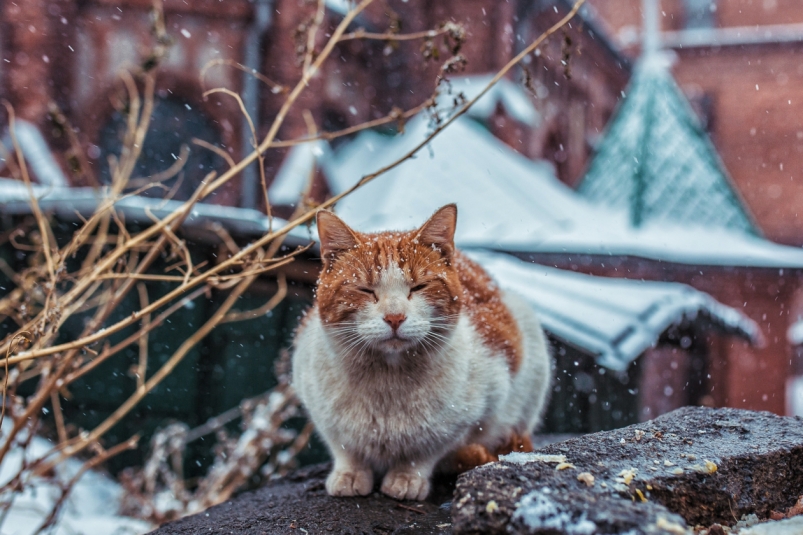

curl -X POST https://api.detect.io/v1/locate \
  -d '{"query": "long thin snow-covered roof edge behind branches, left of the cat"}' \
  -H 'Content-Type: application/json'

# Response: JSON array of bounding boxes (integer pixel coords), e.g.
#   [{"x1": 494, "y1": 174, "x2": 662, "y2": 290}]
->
[{"x1": 0, "y1": 178, "x2": 311, "y2": 248}]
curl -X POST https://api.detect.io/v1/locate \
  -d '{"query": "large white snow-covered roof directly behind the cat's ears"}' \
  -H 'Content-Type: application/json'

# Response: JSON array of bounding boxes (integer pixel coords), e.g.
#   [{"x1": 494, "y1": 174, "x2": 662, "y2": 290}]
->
[{"x1": 322, "y1": 116, "x2": 803, "y2": 268}]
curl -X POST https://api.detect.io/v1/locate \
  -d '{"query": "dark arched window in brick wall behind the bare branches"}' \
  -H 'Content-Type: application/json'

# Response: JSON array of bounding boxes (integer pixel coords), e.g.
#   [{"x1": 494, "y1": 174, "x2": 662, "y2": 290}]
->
[{"x1": 98, "y1": 97, "x2": 225, "y2": 200}]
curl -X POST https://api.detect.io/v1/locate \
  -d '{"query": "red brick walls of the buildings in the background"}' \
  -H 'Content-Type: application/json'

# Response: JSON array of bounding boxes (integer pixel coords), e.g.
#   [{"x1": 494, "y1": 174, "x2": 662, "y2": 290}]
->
[{"x1": 0, "y1": 0, "x2": 803, "y2": 413}]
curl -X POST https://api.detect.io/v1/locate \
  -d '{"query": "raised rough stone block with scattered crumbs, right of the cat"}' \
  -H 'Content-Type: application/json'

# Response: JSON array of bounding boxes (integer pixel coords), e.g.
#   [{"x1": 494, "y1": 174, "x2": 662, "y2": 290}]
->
[{"x1": 452, "y1": 407, "x2": 803, "y2": 535}]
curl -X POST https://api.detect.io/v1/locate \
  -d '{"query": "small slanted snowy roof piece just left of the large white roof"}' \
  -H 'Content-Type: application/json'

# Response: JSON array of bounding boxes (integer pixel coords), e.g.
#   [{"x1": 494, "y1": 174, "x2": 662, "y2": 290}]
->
[{"x1": 268, "y1": 140, "x2": 330, "y2": 205}]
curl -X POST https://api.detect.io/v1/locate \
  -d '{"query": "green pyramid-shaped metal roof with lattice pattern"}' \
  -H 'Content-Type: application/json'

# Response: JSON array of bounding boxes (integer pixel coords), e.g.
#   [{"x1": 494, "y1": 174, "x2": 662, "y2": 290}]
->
[{"x1": 578, "y1": 58, "x2": 759, "y2": 234}]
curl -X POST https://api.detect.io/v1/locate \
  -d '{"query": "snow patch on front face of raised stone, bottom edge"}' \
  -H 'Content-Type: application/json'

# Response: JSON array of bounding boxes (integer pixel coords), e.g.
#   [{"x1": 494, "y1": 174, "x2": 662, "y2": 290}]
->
[{"x1": 513, "y1": 488, "x2": 597, "y2": 535}]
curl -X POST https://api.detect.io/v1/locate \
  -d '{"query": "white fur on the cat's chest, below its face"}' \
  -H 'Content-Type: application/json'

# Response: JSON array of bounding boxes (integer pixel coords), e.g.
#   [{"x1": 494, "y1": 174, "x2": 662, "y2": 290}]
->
[{"x1": 293, "y1": 311, "x2": 511, "y2": 469}]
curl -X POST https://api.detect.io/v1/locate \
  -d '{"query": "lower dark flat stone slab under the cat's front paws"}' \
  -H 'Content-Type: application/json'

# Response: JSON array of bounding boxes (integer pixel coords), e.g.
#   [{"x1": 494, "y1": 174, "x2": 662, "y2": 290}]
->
[{"x1": 152, "y1": 464, "x2": 454, "y2": 535}]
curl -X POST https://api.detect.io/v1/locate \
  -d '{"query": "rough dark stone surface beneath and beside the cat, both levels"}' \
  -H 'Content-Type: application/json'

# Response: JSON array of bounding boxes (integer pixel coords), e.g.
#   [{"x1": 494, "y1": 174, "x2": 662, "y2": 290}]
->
[{"x1": 153, "y1": 407, "x2": 803, "y2": 535}]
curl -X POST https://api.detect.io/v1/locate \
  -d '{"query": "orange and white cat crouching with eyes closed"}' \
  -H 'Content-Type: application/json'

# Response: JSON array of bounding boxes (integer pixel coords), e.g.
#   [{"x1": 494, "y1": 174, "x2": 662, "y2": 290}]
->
[{"x1": 292, "y1": 204, "x2": 552, "y2": 500}]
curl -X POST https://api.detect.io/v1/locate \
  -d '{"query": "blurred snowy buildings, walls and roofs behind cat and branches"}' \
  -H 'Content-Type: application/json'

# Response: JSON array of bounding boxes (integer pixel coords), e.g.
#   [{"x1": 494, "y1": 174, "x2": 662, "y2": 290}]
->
[{"x1": 0, "y1": 0, "x2": 803, "y2": 532}]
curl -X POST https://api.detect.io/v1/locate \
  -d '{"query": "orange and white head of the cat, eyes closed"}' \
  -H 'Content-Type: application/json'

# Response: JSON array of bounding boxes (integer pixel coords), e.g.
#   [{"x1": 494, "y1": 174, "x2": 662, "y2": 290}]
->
[{"x1": 317, "y1": 204, "x2": 461, "y2": 355}]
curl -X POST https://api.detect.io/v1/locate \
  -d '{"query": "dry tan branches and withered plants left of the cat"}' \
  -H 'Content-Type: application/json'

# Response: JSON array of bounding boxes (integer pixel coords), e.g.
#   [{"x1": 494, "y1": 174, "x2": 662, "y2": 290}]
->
[{"x1": 0, "y1": 0, "x2": 583, "y2": 529}]
